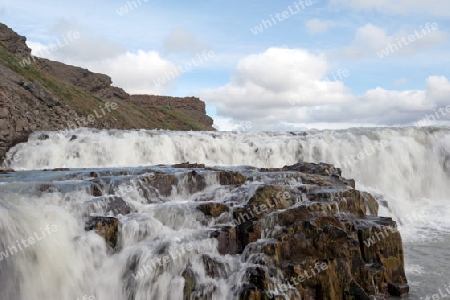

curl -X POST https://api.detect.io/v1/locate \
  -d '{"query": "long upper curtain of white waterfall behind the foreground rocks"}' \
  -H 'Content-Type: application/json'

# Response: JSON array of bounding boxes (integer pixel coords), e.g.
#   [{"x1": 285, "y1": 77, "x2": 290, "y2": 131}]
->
[{"x1": 6, "y1": 128, "x2": 450, "y2": 204}]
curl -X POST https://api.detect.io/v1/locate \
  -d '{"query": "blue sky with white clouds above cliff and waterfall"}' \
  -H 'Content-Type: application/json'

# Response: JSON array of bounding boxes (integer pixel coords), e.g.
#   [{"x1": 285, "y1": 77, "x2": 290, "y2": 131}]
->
[{"x1": 0, "y1": 0, "x2": 450, "y2": 131}]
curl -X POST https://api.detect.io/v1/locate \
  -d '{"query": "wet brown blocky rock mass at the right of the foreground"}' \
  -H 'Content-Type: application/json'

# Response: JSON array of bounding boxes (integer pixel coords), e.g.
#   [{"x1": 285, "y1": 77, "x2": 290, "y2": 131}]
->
[{"x1": 200, "y1": 163, "x2": 408, "y2": 299}]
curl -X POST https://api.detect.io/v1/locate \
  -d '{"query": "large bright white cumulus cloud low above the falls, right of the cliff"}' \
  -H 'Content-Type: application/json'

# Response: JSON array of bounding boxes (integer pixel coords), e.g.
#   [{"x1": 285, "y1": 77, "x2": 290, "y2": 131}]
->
[{"x1": 201, "y1": 48, "x2": 450, "y2": 130}]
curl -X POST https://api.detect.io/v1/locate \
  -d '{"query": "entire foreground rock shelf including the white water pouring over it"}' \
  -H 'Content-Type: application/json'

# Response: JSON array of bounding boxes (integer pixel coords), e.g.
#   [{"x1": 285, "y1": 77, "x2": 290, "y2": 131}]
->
[{"x1": 0, "y1": 158, "x2": 408, "y2": 300}]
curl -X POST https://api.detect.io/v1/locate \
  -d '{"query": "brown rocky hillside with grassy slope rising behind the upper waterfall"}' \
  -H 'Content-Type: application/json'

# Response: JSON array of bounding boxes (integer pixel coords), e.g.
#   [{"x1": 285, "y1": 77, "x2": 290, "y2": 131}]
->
[{"x1": 0, "y1": 23, "x2": 214, "y2": 162}]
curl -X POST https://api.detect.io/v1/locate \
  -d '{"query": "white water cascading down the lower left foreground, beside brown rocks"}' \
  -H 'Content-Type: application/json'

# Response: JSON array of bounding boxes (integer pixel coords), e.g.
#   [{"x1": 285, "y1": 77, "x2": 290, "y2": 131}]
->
[{"x1": 0, "y1": 171, "x2": 246, "y2": 300}]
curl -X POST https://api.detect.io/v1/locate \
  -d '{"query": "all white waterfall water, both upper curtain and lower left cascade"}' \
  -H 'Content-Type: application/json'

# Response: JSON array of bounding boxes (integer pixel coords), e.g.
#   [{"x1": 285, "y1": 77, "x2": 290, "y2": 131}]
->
[{"x1": 0, "y1": 128, "x2": 450, "y2": 300}]
